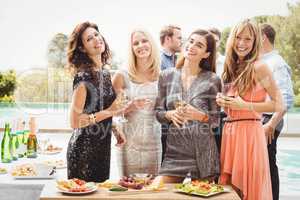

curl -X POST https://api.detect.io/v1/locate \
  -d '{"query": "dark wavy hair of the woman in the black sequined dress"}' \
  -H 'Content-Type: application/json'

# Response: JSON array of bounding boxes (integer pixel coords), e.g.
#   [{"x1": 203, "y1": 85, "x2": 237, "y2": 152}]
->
[{"x1": 67, "y1": 21, "x2": 111, "y2": 79}]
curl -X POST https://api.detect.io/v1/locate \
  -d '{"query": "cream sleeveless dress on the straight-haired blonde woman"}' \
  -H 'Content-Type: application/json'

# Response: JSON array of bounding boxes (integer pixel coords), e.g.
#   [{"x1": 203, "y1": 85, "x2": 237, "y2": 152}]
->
[{"x1": 117, "y1": 71, "x2": 162, "y2": 176}]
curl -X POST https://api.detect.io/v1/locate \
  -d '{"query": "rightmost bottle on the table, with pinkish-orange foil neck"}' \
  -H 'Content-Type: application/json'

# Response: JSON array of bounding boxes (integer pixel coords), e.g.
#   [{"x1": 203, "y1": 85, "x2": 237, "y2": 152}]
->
[{"x1": 27, "y1": 117, "x2": 37, "y2": 158}]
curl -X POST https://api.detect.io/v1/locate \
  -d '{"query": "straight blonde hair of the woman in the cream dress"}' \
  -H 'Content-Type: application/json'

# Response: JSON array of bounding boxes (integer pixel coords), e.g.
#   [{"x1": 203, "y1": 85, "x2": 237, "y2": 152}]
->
[{"x1": 128, "y1": 29, "x2": 160, "y2": 81}]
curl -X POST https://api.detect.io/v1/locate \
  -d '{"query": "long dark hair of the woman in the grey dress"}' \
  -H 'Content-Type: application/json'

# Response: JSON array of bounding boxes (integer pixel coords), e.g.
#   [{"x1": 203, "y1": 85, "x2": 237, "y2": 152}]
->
[{"x1": 176, "y1": 29, "x2": 216, "y2": 72}]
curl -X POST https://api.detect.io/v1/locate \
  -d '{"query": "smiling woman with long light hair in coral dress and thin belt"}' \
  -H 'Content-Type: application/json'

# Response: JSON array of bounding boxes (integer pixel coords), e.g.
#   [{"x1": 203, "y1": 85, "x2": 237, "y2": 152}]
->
[{"x1": 217, "y1": 20, "x2": 283, "y2": 200}]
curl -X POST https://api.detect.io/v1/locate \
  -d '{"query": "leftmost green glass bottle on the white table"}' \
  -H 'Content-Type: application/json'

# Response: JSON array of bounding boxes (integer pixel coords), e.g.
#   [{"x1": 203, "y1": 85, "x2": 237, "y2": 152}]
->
[{"x1": 1, "y1": 123, "x2": 12, "y2": 163}]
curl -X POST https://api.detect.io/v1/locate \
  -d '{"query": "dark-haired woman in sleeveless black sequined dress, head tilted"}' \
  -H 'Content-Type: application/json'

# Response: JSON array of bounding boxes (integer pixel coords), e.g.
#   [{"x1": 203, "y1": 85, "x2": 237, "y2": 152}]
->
[{"x1": 67, "y1": 22, "x2": 125, "y2": 182}]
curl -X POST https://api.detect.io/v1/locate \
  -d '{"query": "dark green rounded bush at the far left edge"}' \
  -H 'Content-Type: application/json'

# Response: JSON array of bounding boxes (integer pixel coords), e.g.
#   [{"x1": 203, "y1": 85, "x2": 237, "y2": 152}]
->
[{"x1": 0, "y1": 70, "x2": 17, "y2": 97}]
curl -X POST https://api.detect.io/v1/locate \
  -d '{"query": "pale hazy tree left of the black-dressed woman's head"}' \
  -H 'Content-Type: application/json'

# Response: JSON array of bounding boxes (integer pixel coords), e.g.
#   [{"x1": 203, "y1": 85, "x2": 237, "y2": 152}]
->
[{"x1": 47, "y1": 33, "x2": 68, "y2": 69}]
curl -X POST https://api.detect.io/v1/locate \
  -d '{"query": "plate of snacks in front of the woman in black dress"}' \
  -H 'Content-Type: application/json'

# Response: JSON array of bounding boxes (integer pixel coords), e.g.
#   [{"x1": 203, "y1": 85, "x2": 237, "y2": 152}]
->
[{"x1": 56, "y1": 178, "x2": 95, "y2": 192}]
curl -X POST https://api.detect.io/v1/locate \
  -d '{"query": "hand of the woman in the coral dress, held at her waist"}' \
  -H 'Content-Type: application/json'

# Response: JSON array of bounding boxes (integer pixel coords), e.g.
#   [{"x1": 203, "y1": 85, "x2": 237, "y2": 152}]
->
[{"x1": 217, "y1": 96, "x2": 247, "y2": 110}]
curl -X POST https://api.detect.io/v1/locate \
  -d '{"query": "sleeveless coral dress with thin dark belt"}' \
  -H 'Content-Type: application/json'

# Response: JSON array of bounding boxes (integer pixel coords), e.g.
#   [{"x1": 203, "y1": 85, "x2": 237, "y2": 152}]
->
[{"x1": 219, "y1": 84, "x2": 272, "y2": 200}]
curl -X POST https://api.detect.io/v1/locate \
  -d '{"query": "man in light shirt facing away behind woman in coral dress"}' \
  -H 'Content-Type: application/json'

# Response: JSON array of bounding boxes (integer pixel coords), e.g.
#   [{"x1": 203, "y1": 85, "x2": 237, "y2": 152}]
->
[{"x1": 261, "y1": 24, "x2": 294, "y2": 200}]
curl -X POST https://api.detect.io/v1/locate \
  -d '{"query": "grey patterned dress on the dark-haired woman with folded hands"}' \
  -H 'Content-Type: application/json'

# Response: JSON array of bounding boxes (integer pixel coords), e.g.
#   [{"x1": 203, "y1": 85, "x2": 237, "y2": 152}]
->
[{"x1": 155, "y1": 69, "x2": 221, "y2": 178}]
